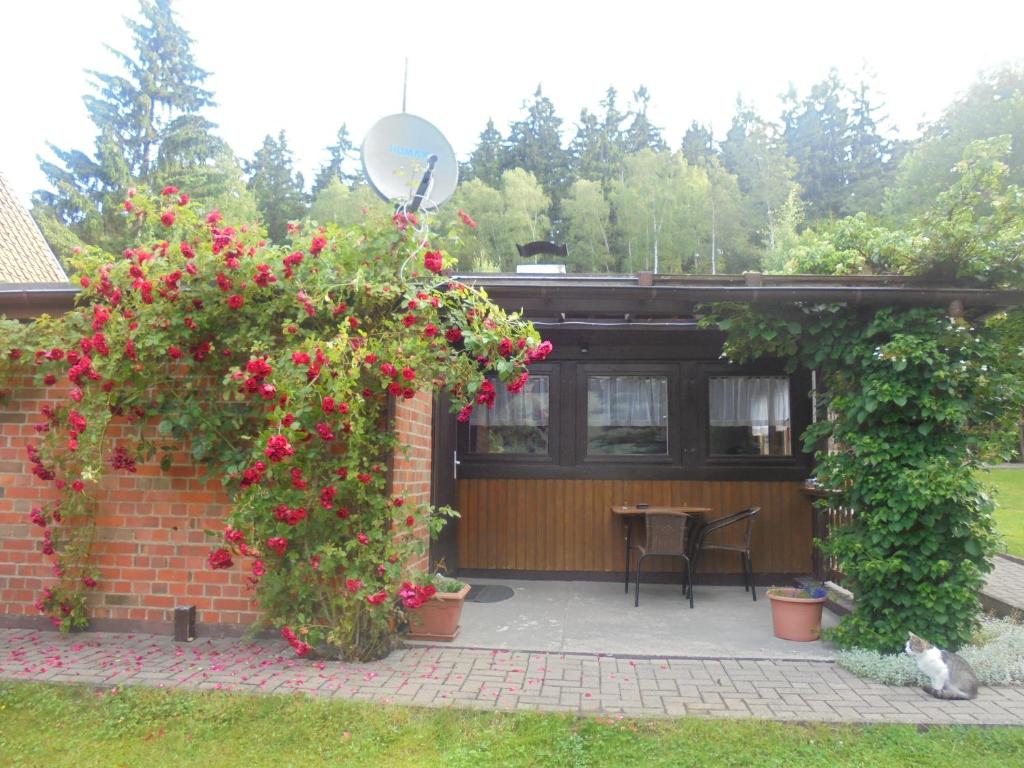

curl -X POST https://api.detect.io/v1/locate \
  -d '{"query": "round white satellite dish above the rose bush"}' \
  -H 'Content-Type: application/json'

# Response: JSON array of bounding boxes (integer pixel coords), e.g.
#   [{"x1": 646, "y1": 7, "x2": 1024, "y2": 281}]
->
[{"x1": 362, "y1": 113, "x2": 459, "y2": 211}]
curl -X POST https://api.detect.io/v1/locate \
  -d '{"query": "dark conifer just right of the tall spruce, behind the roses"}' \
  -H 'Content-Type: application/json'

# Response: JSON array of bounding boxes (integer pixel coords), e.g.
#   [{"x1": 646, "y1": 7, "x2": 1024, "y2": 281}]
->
[{"x1": 246, "y1": 131, "x2": 306, "y2": 243}]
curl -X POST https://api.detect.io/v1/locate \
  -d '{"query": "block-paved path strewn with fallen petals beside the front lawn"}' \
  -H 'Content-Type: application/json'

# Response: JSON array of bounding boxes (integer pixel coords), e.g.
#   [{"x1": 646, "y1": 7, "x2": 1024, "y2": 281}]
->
[{"x1": 0, "y1": 629, "x2": 1024, "y2": 725}]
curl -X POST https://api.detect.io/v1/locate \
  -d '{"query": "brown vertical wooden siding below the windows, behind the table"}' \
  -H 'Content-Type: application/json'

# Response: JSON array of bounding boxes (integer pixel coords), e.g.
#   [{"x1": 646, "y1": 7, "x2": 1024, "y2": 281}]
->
[{"x1": 458, "y1": 479, "x2": 811, "y2": 573}]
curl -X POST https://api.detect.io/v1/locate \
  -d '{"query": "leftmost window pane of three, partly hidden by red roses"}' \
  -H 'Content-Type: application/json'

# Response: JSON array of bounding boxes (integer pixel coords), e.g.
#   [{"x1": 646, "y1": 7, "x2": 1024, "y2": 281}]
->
[{"x1": 469, "y1": 376, "x2": 549, "y2": 454}]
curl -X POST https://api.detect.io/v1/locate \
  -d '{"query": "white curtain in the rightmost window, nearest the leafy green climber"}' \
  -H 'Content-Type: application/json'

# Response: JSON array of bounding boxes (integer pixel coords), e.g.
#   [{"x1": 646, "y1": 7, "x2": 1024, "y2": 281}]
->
[{"x1": 710, "y1": 376, "x2": 790, "y2": 435}]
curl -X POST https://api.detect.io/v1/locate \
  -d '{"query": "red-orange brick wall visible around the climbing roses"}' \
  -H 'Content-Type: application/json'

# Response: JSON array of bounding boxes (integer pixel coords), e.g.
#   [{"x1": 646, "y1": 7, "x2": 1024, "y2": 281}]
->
[{"x1": 0, "y1": 386, "x2": 431, "y2": 635}]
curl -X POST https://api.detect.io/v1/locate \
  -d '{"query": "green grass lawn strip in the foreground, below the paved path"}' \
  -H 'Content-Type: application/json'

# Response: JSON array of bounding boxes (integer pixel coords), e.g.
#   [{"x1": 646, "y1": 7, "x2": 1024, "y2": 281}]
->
[{"x1": 0, "y1": 683, "x2": 1024, "y2": 768}]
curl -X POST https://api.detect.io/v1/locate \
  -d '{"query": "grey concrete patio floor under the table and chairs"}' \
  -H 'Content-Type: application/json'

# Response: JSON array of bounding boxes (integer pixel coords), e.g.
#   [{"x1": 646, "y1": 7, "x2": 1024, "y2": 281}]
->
[{"x1": 413, "y1": 579, "x2": 839, "y2": 660}]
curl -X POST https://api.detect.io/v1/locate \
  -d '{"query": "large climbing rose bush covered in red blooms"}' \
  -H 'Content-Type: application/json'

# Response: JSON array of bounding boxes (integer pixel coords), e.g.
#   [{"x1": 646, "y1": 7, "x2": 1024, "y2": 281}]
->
[{"x1": 0, "y1": 187, "x2": 551, "y2": 659}]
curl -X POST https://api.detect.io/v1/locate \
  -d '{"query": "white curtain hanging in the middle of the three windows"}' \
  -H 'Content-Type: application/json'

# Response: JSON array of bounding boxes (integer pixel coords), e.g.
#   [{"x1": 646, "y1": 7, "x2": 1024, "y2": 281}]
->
[{"x1": 587, "y1": 376, "x2": 669, "y2": 427}]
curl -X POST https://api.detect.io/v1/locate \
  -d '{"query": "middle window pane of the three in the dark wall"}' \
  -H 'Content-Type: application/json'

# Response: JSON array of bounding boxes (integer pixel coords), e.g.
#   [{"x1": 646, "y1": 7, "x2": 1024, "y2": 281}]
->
[{"x1": 587, "y1": 376, "x2": 669, "y2": 456}]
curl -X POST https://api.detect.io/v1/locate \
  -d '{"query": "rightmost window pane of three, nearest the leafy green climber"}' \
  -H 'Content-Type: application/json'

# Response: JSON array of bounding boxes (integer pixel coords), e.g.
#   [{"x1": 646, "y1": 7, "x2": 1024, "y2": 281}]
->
[{"x1": 708, "y1": 376, "x2": 793, "y2": 456}]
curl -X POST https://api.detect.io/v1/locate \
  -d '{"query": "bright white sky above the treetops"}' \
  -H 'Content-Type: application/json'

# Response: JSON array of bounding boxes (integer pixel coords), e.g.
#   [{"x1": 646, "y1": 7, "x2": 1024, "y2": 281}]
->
[{"x1": 0, "y1": 0, "x2": 1024, "y2": 201}]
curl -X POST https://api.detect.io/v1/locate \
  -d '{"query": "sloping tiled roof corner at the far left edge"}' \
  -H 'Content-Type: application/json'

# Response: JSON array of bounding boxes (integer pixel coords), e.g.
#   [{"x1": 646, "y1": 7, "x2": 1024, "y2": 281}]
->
[{"x1": 0, "y1": 173, "x2": 68, "y2": 286}]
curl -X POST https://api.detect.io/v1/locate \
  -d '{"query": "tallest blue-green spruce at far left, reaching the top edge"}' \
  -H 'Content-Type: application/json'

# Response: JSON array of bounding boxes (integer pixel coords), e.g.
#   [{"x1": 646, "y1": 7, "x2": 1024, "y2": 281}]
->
[{"x1": 33, "y1": 0, "x2": 224, "y2": 259}]
